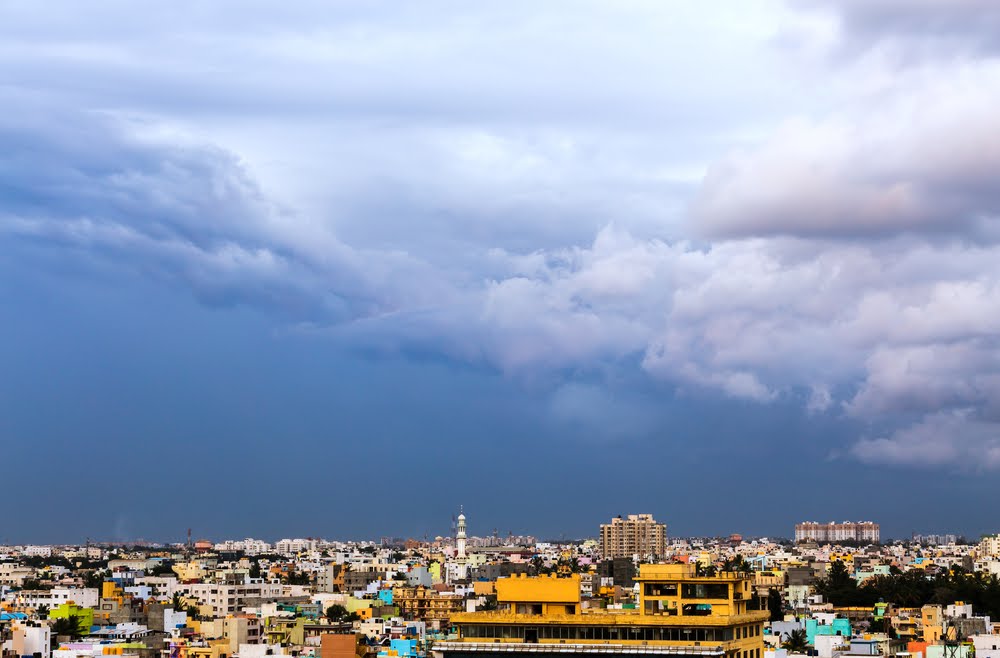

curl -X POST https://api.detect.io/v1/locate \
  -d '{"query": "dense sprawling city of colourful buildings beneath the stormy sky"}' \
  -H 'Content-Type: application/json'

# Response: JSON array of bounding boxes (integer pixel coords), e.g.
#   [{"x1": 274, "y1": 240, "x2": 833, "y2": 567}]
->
[{"x1": 0, "y1": 509, "x2": 1000, "y2": 658}]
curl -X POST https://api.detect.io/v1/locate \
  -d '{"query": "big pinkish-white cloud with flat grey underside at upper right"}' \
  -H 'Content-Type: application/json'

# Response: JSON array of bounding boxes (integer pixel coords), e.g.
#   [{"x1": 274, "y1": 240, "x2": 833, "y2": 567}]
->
[{"x1": 695, "y1": 61, "x2": 1000, "y2": 240}]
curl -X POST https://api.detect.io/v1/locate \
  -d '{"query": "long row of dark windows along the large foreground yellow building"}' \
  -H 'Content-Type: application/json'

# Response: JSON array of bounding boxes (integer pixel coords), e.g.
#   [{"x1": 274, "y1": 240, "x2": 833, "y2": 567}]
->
[{"x1": 461, "y1": 624, "x2": 749, "y2": 642}]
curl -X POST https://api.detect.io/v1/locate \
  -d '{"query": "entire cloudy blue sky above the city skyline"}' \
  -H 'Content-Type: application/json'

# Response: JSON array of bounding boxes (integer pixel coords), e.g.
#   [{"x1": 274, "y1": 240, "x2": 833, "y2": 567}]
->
[{"x1": 0, "y1": 0, "x2": 1000, "y2": 544}]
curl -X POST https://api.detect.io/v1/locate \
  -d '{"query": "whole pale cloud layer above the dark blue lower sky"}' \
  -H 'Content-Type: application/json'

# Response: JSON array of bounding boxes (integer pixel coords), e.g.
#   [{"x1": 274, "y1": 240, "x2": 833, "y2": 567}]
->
[{"x1": 0, "y1": 2, "x2": 1000, "y2": 469}]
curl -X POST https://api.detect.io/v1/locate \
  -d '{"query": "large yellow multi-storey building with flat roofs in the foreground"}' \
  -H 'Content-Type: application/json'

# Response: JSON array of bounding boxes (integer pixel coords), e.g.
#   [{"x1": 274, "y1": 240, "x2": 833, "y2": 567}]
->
[{"x1": 434, "y1": 564, "x2": 768, "y2": 658}]
